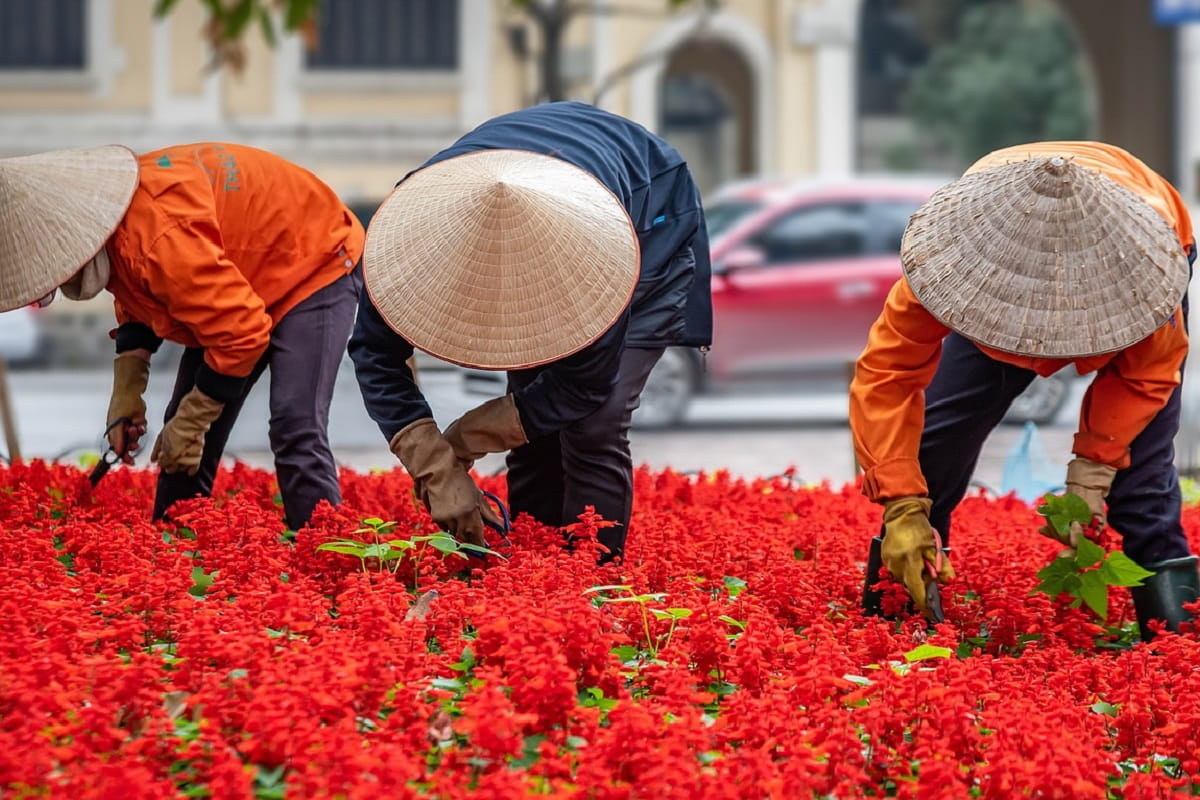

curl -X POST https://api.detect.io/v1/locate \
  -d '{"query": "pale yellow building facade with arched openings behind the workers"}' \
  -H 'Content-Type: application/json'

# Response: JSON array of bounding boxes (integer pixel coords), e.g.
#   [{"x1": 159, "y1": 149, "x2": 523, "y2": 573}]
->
[{"x1": 0, "y1": 0, "x2": 1200, "y2": 355}]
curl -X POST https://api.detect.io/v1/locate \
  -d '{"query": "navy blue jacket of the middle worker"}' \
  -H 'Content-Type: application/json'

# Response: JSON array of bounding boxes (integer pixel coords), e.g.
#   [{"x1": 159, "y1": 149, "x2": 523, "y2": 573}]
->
[{"x1": 349, "y1": 102, "x2": 713, "y2": 440}]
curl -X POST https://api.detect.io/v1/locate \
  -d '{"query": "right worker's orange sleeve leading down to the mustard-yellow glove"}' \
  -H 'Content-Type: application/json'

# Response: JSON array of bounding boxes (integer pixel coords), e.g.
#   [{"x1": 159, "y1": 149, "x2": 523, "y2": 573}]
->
[{"x1": 850, "y1": 278, "x2": 949, "y2": 501}]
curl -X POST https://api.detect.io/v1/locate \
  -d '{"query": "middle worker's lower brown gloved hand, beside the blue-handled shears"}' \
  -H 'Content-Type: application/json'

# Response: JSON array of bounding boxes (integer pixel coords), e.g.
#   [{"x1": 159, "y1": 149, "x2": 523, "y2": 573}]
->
[{"x1": 390, "y1": 417, "x2": 500, "y2": 547}]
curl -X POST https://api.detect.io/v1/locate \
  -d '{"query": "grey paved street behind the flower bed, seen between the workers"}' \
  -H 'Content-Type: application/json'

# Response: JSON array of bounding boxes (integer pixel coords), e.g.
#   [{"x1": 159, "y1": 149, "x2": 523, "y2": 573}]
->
[{"x1": 0, "y1": 362, "x2": 1084, "y2": 496}]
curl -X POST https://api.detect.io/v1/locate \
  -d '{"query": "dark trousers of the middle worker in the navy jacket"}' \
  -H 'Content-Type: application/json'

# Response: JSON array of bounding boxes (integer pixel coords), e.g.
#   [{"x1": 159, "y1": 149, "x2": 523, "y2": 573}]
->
[{"x1": 508, "y1": 348, "x2": 664, "y2": 558}]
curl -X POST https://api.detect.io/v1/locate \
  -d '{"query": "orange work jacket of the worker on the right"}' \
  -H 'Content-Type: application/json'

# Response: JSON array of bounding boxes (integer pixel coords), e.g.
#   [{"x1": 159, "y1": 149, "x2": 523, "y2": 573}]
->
[{"x1": 850, "y1": 142, "x2": 1194, "y2": 501}]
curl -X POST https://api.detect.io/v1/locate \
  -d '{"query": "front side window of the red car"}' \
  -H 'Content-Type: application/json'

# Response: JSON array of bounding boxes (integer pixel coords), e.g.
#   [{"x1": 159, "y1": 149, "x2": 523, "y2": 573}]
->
[{"x1": 751, "y1": 203, "x2": 869, "y2": 264}]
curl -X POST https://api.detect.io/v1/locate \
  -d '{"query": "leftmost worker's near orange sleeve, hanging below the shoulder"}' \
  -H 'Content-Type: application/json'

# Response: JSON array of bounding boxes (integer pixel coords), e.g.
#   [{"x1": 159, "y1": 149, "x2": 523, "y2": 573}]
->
[{"x1": 146, "y1": 217, "x2": 271, "y2": 378}]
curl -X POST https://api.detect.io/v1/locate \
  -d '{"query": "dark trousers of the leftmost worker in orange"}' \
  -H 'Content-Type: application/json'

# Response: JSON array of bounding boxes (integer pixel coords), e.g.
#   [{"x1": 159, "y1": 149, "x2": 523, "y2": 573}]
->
[{"x1": 154, "y1": 269, "x2": 362, "y2": 530}]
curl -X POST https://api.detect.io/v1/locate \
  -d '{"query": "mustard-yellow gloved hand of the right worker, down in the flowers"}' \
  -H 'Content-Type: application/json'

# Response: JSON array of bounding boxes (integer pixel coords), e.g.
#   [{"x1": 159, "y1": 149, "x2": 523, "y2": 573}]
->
[{"x1": 880, "y1": 497, "x2": 954, "y2": 616}]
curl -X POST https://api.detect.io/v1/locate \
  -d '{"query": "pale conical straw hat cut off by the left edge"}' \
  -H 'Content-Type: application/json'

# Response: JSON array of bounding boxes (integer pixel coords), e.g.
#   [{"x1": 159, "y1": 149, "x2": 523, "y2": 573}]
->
[{"x1": 0, "y1": 145, "x2": 138, "y2": 311}]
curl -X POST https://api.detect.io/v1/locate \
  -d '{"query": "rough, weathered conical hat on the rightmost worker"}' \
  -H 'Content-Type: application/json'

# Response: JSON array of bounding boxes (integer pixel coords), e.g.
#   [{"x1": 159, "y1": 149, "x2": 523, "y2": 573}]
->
[{"x1": 901, "y1": 157, "x2": 1188, "y2": 359}]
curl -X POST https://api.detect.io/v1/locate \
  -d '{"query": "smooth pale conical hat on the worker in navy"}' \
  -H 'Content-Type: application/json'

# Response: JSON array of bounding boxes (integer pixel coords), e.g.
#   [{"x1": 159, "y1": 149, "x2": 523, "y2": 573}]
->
[{"x1": 362, "y1": 150, "x2": 640, "y2": 369}]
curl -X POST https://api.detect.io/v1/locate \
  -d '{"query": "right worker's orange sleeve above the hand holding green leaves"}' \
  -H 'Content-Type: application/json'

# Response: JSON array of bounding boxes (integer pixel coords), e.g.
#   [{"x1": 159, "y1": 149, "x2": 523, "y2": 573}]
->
[{"x1": 1072, "y1": 311, "x2": 1188, "y2": 469}]
